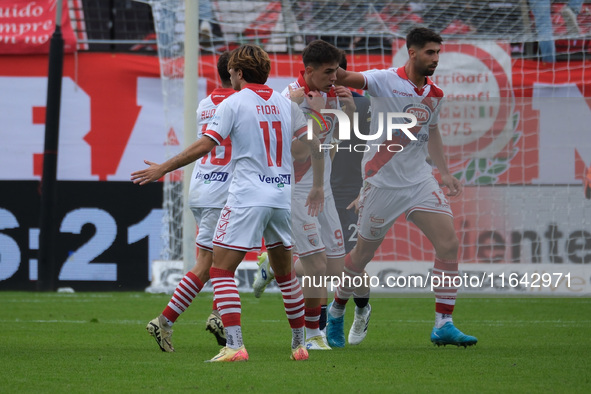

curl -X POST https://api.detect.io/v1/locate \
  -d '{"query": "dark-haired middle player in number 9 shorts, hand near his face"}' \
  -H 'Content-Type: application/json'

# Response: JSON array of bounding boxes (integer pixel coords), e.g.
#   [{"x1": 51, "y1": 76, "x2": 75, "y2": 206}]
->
[{"x1": 254, "y1": 40, "x2": 367, "y2": 350}]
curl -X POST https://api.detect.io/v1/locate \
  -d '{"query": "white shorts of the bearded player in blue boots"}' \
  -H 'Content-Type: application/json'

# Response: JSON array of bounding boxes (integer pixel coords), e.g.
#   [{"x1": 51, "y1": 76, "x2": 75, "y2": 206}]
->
[{"x1": 357, "y1": 178, "x2": 453, "y2": 241}]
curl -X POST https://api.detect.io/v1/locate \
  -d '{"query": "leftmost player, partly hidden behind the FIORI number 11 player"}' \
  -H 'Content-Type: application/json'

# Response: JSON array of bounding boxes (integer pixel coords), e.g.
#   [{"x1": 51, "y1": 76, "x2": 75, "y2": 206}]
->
[{"x1": 146, "y1": 52, "x2": 235, "y2": 352}]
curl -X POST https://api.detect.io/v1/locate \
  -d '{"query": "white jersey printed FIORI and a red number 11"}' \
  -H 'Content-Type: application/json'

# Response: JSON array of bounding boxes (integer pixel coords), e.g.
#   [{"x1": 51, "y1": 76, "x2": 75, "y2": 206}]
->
[{"x1": 204, "y1": 84, "x2": 307, "y2": 209}]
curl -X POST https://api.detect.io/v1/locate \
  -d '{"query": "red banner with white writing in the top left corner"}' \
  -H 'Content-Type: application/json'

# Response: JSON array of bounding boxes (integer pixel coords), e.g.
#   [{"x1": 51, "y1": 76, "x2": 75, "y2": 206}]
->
[{"x1": 0, "y1": 0, "x2": 76, "y2": 54}]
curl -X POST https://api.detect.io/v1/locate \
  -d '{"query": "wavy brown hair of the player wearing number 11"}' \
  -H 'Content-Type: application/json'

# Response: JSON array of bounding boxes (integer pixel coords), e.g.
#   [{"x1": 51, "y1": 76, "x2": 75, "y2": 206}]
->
[{"x1": 228, "y1": 44, "x2": 271, "y2": 84}]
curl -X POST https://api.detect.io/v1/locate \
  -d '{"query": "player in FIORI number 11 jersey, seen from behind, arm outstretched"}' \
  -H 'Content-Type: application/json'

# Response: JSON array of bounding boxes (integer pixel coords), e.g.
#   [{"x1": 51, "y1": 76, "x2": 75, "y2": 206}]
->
[{"x1": 132, "y1": 45, "x2": 324, "y2": 362}]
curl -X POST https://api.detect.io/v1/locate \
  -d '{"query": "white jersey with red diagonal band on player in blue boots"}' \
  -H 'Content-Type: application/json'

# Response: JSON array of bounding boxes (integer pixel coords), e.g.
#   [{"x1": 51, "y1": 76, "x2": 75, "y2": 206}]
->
[{"x1": 362, "y1": 67, "x2": 443, "y2": 188}]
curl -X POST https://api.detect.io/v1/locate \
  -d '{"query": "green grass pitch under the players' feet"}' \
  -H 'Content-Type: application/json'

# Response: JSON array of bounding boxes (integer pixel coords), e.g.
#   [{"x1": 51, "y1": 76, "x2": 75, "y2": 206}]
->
[{"x1": 0, "y1": 292, "x2": 591, "y2": 393}]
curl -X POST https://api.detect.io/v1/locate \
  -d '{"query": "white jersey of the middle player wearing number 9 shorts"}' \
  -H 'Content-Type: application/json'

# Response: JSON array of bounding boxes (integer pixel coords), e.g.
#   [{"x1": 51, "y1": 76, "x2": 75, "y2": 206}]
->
[{"x1": 281, "y1": 71, "x2": 340, "y2": 197}]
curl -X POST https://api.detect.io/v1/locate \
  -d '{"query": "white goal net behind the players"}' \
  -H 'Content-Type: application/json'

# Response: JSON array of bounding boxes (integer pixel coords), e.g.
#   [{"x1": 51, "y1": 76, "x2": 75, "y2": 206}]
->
[{"x1": 150, "y1": 0, "x2": 591, "y2": 284}]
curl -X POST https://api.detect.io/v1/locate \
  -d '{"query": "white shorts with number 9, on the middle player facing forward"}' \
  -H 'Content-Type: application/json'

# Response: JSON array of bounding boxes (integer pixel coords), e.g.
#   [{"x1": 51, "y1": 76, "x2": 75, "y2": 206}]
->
[{"x1": 291, "y1": 196, "x2": 345, "y2": 259}]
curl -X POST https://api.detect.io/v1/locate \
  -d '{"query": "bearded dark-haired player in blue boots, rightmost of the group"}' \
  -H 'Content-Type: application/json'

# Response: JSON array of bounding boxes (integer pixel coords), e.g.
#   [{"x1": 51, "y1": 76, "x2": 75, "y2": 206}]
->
[{"x1": 327, "y1": 28, "x2": 477, "y2": 346}]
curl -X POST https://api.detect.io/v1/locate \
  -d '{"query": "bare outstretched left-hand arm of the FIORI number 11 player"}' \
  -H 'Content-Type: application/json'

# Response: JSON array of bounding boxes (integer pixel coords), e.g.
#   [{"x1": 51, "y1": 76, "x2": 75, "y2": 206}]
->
[{"x1": 131, "y1": 136, "x2": 216, "y2": 185}]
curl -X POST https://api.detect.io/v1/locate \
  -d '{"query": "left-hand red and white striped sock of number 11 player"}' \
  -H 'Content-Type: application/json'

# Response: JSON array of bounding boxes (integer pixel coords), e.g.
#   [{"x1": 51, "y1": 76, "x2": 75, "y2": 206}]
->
[{"x1": 209, "y1": 267, "x2": 242, "y2": 327}]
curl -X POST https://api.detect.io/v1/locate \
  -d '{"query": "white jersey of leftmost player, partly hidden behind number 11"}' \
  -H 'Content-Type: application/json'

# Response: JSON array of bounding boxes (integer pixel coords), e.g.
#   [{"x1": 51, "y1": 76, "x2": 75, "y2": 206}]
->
[{"x1": 189, "y1": 88, "x2": 236, "y2": 208}]
